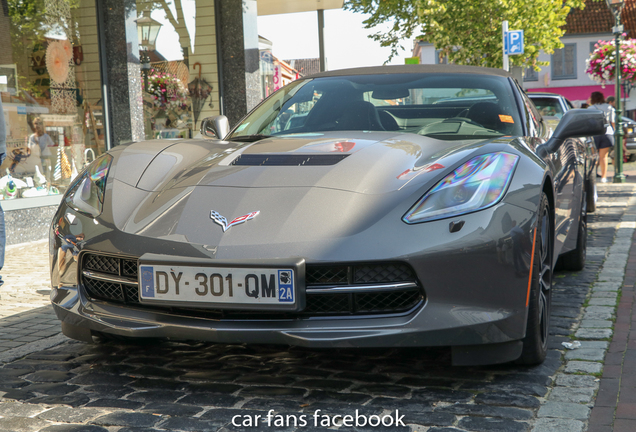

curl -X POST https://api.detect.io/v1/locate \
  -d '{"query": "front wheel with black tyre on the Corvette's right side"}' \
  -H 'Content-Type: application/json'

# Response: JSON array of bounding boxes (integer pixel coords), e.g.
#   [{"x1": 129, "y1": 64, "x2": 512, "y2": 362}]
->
[{"x1": 516, "y1": 193, "x2": 554, "y2": 365}]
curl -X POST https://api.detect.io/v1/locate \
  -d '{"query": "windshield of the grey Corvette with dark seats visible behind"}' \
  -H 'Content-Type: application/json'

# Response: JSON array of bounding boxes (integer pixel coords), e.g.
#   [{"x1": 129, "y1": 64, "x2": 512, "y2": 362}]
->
[{"x1": 230, "y1": 74, "x2": 522, "y2": 140}]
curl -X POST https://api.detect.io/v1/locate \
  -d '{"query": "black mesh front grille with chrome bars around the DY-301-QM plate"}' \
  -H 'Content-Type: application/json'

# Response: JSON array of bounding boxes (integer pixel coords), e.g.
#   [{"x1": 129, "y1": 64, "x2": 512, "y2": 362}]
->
[{"x1": 82, "y1": 253, "x2": 424, "y2": 319}]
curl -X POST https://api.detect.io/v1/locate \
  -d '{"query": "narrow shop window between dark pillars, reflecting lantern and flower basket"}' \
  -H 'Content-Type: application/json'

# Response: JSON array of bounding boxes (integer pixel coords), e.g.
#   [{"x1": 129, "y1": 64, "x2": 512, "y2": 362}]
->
[{"x1": 126, "y1": 0, "x2": 219, "y2": 139}]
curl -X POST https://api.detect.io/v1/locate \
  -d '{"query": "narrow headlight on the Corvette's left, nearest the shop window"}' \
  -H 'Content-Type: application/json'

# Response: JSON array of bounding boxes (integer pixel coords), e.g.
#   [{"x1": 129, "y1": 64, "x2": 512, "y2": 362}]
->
[{"x1": 65, "y1": 154, "x2": 113, "y2": 217}]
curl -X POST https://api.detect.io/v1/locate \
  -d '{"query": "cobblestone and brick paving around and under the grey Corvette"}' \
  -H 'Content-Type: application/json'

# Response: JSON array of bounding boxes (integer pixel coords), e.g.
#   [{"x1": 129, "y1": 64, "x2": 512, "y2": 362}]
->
[{"x1": 0, "y1": 184, "x2": 636, "y2": 432}]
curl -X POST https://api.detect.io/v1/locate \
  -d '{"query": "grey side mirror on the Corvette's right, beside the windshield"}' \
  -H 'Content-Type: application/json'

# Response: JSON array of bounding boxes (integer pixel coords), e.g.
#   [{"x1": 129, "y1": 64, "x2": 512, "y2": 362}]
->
[{"x1": 537, "y1": 109, "x2": 607, "y2": 156}]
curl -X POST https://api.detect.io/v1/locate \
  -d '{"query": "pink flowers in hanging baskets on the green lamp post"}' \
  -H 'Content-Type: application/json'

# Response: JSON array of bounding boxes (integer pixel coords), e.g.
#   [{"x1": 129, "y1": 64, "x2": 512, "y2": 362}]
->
[{"x1": 585, "y1": 39, "x2": 636, "y2": 84}]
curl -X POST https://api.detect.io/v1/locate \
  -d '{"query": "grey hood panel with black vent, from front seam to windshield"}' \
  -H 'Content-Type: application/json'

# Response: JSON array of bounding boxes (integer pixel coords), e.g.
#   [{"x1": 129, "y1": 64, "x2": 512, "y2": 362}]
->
[{"x1": 116, "y1": 132, "x2": 510, "y2": 194}]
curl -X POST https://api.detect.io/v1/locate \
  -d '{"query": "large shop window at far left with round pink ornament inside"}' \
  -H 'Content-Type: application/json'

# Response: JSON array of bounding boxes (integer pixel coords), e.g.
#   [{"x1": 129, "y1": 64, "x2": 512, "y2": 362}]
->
[{"x1": 0, "y1": 0, "x2": 106, "y2": 199}]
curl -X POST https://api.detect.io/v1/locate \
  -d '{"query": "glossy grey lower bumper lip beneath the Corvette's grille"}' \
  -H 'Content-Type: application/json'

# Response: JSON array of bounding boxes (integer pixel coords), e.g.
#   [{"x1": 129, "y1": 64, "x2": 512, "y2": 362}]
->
[{"x1": 51, "y1": 287, "x2": 525, "y2": 348}]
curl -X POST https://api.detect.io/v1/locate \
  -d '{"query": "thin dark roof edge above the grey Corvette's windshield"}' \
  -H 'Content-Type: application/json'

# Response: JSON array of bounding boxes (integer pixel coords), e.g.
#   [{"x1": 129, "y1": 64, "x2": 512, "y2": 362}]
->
[{"x1": 305, "y1": 65, "x2": 511, "y2": 78}]
